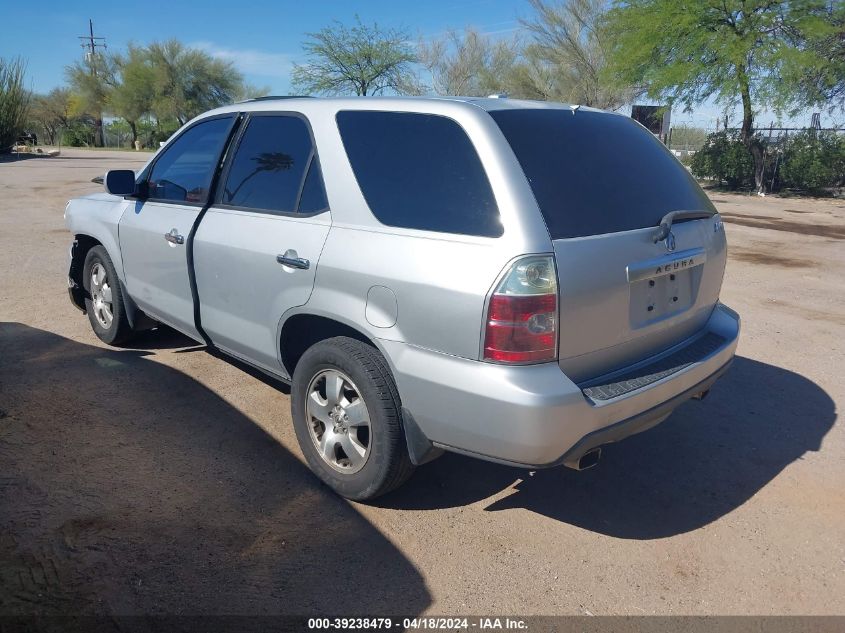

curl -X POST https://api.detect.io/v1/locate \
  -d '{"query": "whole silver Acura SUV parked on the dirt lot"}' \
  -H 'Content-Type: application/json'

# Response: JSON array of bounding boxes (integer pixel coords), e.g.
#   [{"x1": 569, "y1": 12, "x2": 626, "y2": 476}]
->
[{"x1": 66, "y1": 98, "x2": 739, "y2": 500}]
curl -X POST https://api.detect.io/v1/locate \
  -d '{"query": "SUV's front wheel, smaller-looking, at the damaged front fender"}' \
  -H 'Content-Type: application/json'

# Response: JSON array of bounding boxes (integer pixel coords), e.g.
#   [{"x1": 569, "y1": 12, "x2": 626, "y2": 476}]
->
[{"x1": 82, "y1": 246, "x2": 133, "y2": 345}]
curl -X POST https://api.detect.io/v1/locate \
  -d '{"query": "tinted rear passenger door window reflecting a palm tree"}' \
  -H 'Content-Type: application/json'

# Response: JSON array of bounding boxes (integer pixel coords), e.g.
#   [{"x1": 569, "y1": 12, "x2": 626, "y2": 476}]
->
[{"x1": 221, "y1": 115, "x2": 328, "y2": 213}]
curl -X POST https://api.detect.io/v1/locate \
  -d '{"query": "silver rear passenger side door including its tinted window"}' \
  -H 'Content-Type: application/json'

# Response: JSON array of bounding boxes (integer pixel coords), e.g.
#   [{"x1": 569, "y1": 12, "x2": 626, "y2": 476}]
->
[{"x1": 194, "y1": 113, "x2": 331, "y2": 372}]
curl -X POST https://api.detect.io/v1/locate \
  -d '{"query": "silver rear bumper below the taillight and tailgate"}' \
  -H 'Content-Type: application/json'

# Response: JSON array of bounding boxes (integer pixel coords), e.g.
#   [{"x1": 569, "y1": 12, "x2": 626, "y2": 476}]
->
[{"x1": 382, "y1": 304, "x2": 740, "y2": 467}]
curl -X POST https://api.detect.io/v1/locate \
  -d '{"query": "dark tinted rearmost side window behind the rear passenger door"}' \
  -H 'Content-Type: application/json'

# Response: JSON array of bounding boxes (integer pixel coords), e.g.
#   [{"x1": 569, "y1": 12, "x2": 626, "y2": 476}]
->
[{"x1": 337, "y1": 111, "x2": 502, "y2": 237}]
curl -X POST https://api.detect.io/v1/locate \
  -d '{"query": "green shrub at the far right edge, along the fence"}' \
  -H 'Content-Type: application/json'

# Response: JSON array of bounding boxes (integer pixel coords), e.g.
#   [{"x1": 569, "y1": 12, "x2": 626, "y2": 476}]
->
[{"x1": 778, "y1": 130, "x2": 845, "y2": 191}]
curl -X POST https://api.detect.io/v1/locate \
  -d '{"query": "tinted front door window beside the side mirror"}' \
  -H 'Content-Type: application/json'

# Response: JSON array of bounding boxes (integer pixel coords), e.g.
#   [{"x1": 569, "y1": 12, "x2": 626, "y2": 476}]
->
[{"x1": 147, "y1": 117, "x2": 232, "y2": 203}]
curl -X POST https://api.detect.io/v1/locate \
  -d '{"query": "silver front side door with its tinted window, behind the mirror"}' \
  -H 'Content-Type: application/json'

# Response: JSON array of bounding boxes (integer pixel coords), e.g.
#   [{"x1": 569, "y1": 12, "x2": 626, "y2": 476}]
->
[{"x1": 119, "y1": 115, "x2": 234, "y2": 340}]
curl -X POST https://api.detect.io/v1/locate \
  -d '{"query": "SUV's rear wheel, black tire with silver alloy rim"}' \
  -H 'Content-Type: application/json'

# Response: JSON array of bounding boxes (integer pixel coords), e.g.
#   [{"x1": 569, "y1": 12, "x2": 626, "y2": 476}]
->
[{"x1": 291, "y1": 336, "x2": 414, "y2": 501}]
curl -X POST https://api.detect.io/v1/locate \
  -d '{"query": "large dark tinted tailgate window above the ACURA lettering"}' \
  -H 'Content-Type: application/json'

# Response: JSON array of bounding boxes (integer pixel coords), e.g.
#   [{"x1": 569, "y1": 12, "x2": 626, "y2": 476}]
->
[{"x1": 490, "y1": 109, "x2": 715, "y2": 240}]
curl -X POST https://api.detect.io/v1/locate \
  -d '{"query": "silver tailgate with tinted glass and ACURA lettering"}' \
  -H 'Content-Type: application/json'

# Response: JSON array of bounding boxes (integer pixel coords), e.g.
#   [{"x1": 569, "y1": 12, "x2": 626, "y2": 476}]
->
[{"x1": 491, "y1": 109, "x2": 726, "y2": 381}]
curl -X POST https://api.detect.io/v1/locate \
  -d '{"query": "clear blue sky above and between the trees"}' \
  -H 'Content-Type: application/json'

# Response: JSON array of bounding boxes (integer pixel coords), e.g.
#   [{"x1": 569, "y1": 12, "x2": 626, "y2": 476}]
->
[{"x1": 0, "y1": 0, "x2": 829, "y2": 130}]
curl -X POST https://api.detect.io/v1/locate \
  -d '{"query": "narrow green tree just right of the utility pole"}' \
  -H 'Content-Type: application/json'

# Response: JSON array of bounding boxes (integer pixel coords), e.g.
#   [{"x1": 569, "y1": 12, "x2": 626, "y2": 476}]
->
[{"x1": 108, "y1": 44, "x2": 155, "y2": 144}]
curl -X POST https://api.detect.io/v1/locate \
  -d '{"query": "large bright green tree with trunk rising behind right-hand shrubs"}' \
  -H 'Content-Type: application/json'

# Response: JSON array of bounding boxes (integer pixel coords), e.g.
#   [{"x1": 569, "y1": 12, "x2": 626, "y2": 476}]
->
[{"x1": 606, "y1": 0, "x2": 829, "y2": 191}]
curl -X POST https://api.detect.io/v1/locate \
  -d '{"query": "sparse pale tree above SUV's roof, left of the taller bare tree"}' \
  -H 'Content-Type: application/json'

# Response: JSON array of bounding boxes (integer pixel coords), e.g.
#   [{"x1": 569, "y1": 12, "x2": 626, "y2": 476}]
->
[{"x1": 418, "y1": 27, "x2": 544, "y2": 99}]
